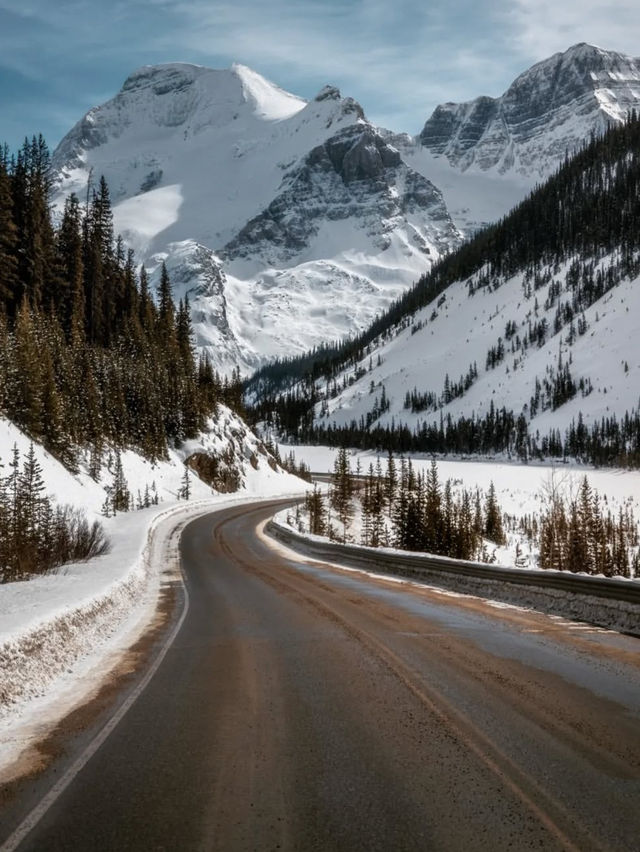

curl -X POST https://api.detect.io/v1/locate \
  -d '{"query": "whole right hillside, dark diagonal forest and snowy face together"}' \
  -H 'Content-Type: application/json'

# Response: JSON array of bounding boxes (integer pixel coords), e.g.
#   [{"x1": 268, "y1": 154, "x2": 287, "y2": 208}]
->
[{"x1": 249, "y1": 118, "x2": 640, "y2": 463}]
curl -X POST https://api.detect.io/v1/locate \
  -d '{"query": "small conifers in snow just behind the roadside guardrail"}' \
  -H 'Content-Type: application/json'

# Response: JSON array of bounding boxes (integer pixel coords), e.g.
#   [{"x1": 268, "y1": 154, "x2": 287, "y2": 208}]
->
[{"x1": 296, "y1": 448, "x2": 640, "y2": 578}]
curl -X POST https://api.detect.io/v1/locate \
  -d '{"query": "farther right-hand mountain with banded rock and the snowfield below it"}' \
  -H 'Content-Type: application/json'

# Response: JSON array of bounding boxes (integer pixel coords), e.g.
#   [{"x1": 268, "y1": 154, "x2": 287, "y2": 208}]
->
[{"x1": 399, "y1": 44, "x2": 640, "y2": 230}]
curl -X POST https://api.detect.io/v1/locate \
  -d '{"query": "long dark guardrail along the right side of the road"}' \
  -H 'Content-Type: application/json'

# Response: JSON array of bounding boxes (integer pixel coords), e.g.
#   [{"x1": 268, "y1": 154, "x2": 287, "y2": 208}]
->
[{"x1": 266, "y1": 520, "x2": 640, "y2": 608}]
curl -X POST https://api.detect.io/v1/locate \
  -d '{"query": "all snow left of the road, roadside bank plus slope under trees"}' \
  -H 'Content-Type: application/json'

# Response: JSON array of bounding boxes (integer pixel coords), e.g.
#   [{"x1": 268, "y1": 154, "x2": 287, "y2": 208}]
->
[{"x1": 0, "y1": 406, "x2": 304, "y2": 772}]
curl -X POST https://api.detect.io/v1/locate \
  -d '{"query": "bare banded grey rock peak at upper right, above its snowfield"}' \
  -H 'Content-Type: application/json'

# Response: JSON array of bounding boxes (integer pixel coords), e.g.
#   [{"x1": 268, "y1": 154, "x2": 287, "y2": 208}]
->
[{"x1": 419, "y1": 44, "x2": 640, "y2": 176}]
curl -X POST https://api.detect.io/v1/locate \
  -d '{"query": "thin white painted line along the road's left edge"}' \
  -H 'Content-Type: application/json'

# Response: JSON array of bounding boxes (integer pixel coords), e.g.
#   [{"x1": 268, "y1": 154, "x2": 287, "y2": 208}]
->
[{"x1": 0, "y1": 528, "x2": 189, "y2": 852}]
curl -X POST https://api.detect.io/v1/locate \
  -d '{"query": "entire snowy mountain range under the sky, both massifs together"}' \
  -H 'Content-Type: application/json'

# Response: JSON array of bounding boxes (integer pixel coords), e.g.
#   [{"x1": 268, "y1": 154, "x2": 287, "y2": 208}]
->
[{"x1": 53, "y1": 45, "x2": 640, "y2": 371}]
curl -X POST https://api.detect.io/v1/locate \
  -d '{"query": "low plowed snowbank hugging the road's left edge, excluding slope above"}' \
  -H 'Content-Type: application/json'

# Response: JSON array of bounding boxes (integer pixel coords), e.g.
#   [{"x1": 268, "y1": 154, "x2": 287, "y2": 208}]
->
[{"x1": 0, "y1": 482, "x2": 300, "y2": 771}]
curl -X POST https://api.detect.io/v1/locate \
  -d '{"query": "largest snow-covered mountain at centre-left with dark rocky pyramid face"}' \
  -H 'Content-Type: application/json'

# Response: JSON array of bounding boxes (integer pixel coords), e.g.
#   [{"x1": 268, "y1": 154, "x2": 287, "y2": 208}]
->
[{"x1": 53, "y1": 63, "x2": 461, "y2": 368}]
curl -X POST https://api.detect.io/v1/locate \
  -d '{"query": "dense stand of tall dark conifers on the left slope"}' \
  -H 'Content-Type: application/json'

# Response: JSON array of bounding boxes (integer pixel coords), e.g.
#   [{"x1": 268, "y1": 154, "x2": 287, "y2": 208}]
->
[{"x1": 0, "y1": 136, "x2": 242, "y2": 475}]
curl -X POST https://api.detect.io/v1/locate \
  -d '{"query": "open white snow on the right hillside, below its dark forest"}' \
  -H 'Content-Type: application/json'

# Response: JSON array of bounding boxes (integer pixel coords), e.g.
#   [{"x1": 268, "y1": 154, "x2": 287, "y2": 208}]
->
[{"x1": 316, "y1": 253, "x2": 640, "y2": 435}]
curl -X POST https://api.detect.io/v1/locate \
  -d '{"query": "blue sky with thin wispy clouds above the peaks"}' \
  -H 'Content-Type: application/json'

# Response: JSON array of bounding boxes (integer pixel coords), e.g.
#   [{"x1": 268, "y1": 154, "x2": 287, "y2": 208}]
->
[{"x1": 0, "y1": 0, "x2": 640, "y2": 148}]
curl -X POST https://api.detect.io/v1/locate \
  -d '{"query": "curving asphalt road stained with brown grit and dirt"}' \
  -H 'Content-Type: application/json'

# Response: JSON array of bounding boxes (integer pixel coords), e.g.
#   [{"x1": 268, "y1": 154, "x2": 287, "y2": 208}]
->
[{"x1": 0, "y1": 504, "x2": 640, "y2": 852}]
